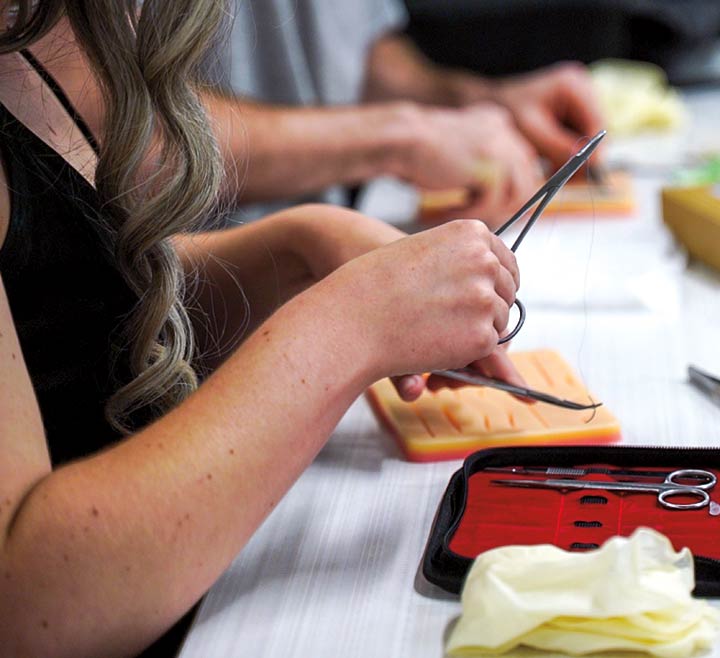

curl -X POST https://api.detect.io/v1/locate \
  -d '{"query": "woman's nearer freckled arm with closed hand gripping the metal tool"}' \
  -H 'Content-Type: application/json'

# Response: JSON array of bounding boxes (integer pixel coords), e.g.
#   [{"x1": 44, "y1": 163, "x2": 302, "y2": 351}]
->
[{"x1": 0, "y1": 159, "x2": 517, "y2": 658}]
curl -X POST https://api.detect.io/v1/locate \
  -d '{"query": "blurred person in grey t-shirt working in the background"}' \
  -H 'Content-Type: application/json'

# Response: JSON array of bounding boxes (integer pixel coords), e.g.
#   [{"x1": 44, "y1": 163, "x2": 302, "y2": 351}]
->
[{"x1": 221, "y1": 0, "x2": 603, "y2": 223}]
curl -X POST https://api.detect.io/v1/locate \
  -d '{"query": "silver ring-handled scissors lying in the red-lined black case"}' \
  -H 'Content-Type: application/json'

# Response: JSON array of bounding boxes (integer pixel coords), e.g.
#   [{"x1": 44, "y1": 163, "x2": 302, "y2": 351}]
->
[{"x1": 492, "y1": 468, "x2": 717, "y2": 510}]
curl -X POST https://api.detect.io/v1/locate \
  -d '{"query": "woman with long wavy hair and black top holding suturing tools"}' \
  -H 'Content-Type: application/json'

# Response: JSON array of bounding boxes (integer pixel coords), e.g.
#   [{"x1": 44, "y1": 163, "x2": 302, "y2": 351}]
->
[{"x1": 0, "y1": 0, "x2": 518, "y2": 658}]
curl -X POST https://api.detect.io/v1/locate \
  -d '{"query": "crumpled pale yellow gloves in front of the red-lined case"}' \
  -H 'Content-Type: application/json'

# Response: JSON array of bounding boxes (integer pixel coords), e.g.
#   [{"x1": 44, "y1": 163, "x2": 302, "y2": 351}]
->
[{"x1": 447, "y1": 528, "x2": 720, "y2": 658}]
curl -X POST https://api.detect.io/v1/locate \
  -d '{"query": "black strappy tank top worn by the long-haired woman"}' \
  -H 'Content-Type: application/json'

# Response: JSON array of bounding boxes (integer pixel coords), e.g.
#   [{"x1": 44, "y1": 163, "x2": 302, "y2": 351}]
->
[{"x1": 0, "y1": 62, "x2": 137, "y2": 465}]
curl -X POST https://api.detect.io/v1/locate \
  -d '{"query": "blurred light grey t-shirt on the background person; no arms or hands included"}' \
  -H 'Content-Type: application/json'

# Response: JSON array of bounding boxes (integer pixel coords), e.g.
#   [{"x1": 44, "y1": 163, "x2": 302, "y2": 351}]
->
[{"x1": 225, "y1": 0, "x2": 407, "y2": 220}]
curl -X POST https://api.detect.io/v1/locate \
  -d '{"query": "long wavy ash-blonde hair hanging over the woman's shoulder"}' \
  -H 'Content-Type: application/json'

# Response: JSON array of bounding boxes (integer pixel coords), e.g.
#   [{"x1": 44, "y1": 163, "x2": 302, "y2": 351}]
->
[{"x1": 0, "y1": 0, "x2": 226, "y2": 433}]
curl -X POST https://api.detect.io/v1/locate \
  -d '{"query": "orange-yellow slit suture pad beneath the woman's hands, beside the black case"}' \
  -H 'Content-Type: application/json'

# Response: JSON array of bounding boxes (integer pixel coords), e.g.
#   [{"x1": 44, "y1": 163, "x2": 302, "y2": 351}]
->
[{"x1": 367, "y1": 350, "x2": 620, "y2": 461}]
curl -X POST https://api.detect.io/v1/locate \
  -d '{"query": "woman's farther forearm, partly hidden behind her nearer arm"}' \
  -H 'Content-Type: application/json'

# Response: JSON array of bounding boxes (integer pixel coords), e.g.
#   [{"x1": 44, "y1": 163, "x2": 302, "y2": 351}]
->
[{"x1": 175, "y1": 204, "x2": 405, "y2": 367}]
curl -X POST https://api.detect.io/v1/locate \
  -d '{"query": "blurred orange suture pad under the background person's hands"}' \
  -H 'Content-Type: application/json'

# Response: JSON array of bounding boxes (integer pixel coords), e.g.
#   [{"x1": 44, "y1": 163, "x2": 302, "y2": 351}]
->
[{"x1": 418, "y1": 171, "x2": 635, "y2": 222}]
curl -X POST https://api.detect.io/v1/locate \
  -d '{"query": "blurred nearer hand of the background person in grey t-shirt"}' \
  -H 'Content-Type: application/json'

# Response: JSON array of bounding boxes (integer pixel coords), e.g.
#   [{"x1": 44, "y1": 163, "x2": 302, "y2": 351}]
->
[{"x1": 397, "y1": 103, "x2": 541, "y2": 226}]
